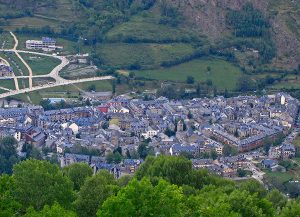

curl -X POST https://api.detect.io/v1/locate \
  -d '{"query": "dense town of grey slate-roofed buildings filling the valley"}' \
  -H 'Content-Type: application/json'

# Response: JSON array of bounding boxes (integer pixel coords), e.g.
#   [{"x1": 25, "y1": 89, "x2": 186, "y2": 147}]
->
[{"x1": 0, "y1": 93, "x2": 300, "y2": 189}]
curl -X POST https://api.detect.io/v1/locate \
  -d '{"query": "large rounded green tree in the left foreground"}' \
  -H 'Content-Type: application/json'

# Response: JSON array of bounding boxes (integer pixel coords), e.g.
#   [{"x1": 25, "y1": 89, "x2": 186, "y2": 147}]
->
[{"x1": 13, "y1": 159, "x2": 74, "y2": 210}]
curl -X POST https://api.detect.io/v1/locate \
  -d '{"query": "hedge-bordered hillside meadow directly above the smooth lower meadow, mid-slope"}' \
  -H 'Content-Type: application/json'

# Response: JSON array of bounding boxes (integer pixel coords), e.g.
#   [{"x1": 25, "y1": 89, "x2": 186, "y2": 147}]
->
[{"x1": 97, "y1": 43, "x2": 194, "y2": 68}]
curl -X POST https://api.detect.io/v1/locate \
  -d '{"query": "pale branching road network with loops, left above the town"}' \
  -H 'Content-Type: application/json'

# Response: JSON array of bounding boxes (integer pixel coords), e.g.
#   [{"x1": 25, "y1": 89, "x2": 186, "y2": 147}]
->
[{"x1": 0, "y1": 32, "x2": 114, "y2": 98}]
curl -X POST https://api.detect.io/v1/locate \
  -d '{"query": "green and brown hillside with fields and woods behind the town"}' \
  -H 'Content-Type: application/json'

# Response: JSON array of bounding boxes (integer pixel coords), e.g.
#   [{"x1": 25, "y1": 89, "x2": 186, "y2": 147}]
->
[{"x1": 0, "y1": 0, "x2": 300, "y2": 96}]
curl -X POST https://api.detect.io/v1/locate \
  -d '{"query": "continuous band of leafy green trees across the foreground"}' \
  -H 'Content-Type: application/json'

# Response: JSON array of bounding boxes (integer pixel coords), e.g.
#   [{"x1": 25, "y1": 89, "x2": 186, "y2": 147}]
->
[{"x1": 0, "y1": 156, "x2": 300, "y2": 217}]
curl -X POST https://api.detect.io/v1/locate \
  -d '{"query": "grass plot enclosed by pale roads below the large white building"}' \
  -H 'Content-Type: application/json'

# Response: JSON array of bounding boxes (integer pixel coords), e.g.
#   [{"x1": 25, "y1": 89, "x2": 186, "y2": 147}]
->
[{"x1": 21, "y1": 54, "x2": 61, "y2": 75}]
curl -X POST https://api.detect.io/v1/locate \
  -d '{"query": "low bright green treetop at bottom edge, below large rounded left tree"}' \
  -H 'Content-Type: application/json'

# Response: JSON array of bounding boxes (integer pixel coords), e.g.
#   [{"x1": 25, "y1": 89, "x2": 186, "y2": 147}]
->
[{"x1": 24, "y1": 203, "x2": 76, "y2": 217}]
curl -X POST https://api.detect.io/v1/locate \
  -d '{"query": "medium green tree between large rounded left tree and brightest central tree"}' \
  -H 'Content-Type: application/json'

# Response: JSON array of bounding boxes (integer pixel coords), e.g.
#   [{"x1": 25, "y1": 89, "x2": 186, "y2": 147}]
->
[{"x1": 75, "y1": 170, "x2": 119, "y2": 217}]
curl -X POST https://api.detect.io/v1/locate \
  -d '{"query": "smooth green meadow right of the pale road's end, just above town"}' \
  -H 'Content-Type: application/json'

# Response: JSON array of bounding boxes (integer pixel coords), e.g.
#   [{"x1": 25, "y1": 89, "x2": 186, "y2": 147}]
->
[{"x1": 135, "y1": 59, "x2": 241, "y2": 90}]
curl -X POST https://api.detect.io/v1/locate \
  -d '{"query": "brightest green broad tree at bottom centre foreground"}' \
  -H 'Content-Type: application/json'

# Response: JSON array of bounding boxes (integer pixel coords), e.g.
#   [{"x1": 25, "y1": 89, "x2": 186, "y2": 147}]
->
[{"x1": 97, "y1": 178, "x2": 184, "y2": 217}]
